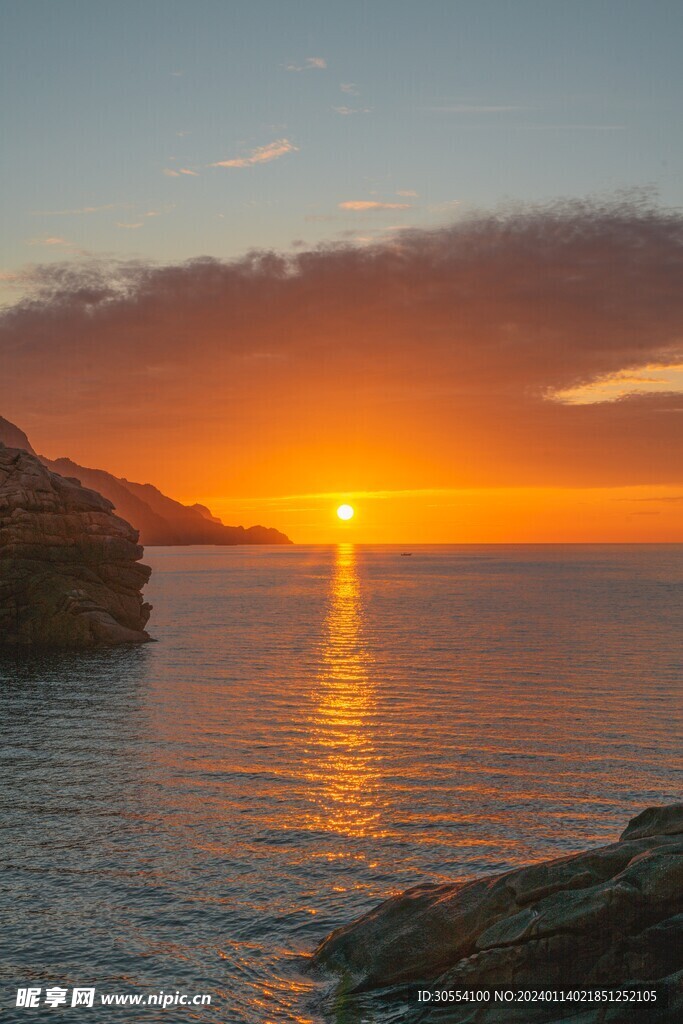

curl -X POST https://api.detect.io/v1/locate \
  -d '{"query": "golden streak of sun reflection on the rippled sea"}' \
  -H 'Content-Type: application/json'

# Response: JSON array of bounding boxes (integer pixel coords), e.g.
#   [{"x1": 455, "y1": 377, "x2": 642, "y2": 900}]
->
[{"x1": 306, "y1": 544, "x2": 382, "y2": 837}]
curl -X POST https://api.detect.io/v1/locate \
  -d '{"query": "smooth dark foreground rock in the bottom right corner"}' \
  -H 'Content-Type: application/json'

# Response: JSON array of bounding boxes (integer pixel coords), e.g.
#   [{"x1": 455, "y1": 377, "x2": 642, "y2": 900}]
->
[{"x1": 312, "y1": 804, "x2": 683, "y2": 1024}]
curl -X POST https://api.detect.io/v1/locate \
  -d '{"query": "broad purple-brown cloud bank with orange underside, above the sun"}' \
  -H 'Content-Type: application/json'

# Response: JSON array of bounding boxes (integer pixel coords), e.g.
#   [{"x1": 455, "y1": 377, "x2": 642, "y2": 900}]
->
[{"x1": 0, "y1": 200, "x2": 683, "y2": 483}]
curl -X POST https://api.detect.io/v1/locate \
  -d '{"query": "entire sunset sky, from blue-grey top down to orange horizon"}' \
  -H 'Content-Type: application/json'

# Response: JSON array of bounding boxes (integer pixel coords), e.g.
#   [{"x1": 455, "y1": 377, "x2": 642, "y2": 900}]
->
[{"x1": 0, "y1": 0, "x2": 683, "y2": 543}]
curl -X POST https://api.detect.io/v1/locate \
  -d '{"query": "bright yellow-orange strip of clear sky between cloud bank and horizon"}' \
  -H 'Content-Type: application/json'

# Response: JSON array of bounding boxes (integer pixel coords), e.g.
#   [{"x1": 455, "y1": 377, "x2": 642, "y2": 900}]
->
[{"x1": 204, "y1": 487, "x2": 683, "y2": 545}]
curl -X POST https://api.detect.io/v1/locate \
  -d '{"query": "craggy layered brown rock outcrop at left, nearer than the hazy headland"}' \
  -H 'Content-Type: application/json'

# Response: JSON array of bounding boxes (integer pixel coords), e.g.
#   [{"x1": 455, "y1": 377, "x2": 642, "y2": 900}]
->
[{"x1": 0, "y1": 443, "x2": 152, "y2": 647}]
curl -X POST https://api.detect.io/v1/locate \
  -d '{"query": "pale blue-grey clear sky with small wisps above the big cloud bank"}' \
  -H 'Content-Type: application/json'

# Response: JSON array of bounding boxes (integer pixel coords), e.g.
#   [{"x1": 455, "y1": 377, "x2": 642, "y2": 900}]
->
[{"x1": 0, "y1": 0, "x2": 683, "y2": 299}]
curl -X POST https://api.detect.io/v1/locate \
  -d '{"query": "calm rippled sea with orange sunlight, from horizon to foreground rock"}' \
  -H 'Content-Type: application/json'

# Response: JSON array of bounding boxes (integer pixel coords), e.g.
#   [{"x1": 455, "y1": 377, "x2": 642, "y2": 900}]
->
[{"x1": 0, "y1": 546, "x2": 683, "y2": 1024}]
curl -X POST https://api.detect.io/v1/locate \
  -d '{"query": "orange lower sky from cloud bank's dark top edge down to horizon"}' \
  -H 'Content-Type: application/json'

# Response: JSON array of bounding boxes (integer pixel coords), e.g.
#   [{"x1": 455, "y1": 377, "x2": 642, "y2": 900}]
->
[{"x1": 0, "y1": 196, "x2": 683, "y2": 544}]
